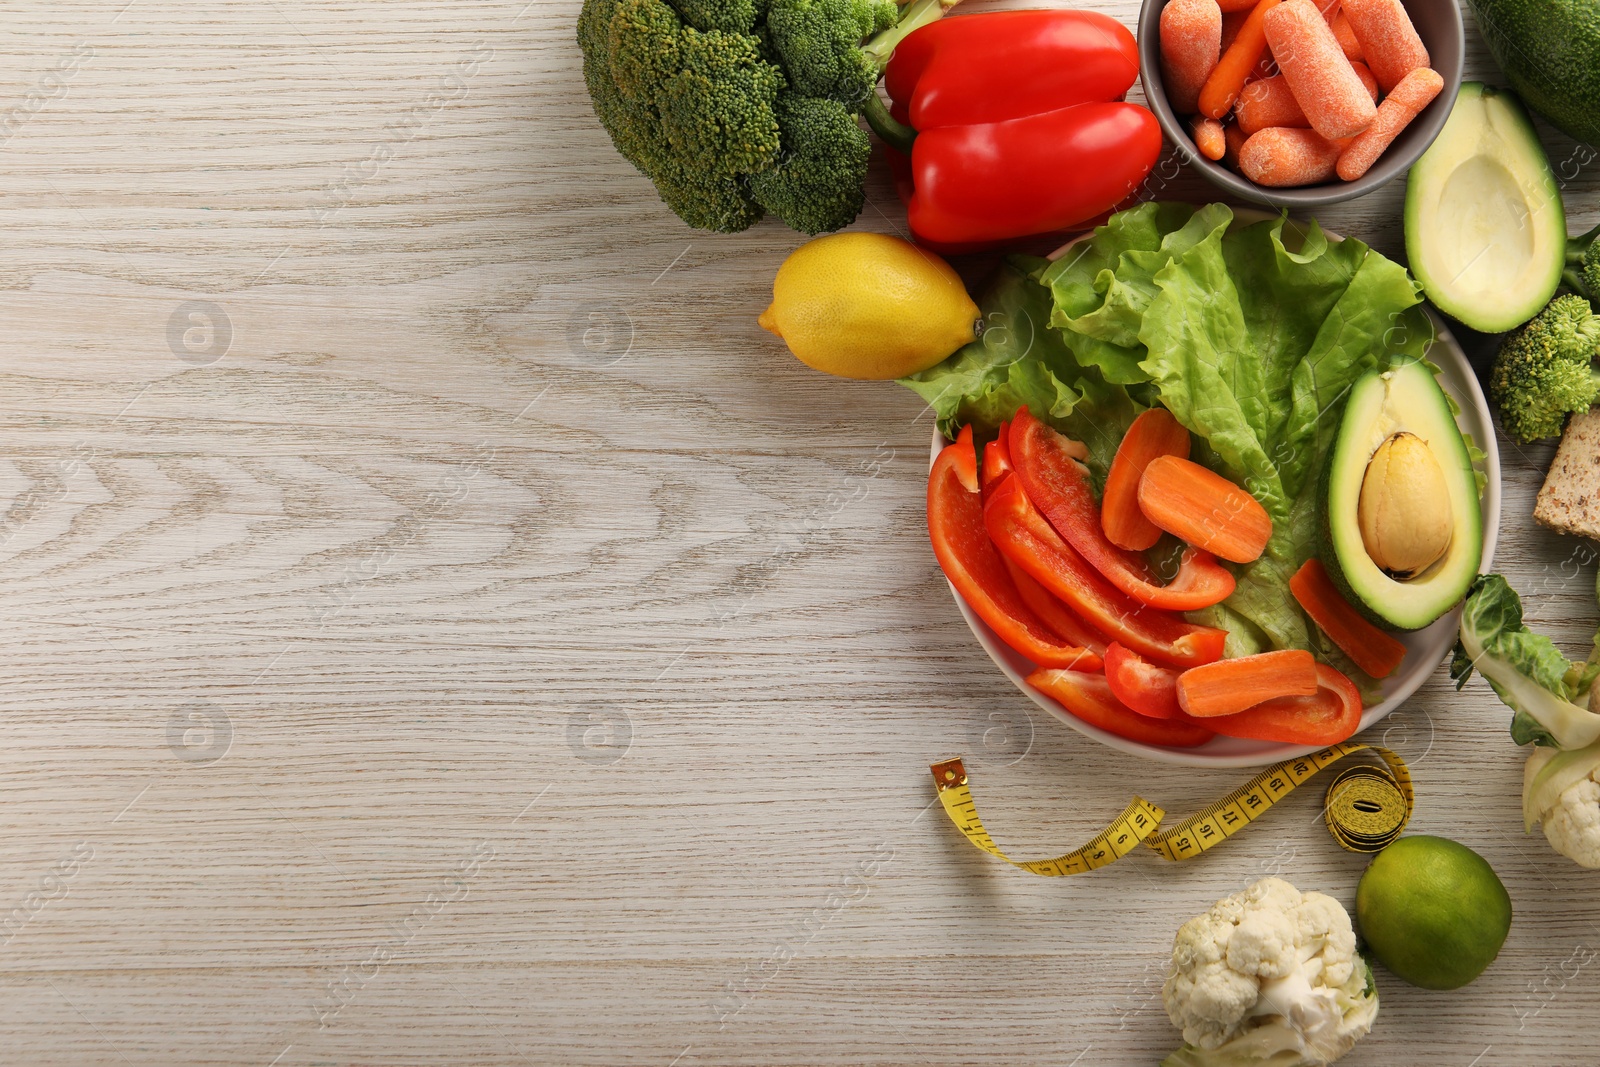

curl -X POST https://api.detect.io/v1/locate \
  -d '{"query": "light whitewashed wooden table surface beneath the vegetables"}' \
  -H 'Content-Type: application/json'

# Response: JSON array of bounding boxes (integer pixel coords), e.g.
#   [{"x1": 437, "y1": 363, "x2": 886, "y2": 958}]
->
[{"x1": 0, "y1": 0, "x2": 1600, "y2": 1067}]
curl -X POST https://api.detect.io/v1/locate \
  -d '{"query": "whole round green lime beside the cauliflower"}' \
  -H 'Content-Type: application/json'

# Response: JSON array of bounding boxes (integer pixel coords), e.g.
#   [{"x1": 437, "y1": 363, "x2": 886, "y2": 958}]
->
[{"x1": 1355, "y1": 835, "x2": 1510, "y2": 989}]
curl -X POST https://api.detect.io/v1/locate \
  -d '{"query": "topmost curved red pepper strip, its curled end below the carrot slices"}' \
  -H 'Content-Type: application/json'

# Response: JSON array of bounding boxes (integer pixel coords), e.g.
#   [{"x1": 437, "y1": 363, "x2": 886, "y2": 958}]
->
[{"x1": 1008, "y1": 408, "x2": 1234, "y2": 611}]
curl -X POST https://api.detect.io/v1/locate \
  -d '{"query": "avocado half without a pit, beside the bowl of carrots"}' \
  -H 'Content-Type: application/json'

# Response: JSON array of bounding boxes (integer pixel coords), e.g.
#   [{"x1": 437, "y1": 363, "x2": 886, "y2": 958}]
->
[{"x1": 1405, "y1": 82, "x2": 1566, "y2": 333}]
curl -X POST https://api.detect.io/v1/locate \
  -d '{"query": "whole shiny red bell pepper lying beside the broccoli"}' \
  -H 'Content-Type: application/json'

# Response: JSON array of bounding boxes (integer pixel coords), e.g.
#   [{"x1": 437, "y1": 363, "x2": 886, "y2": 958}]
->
[{"x1": 866, "y1": 10, "x2": 1162, "y2": 248}]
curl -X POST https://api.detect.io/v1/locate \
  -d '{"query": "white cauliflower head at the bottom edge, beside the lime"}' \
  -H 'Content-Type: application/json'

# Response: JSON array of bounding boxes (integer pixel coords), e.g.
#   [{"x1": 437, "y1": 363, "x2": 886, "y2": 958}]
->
[{"x1": 1162, "y1": 878, "x2": 1378, "y2": 1067}]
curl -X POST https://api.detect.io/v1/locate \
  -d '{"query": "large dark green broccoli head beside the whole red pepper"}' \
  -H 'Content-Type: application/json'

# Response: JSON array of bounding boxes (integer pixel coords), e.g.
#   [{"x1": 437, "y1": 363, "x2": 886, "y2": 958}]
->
[{"x1": 578, "y1": 0, "x2": 958, "y2": 235}]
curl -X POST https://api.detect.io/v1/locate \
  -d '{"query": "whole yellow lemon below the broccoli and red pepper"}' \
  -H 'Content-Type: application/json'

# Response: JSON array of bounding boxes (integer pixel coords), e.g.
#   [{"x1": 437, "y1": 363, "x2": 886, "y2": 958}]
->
[{"x1": 760, "y1": 234, "x2": 978, "y2": 381}]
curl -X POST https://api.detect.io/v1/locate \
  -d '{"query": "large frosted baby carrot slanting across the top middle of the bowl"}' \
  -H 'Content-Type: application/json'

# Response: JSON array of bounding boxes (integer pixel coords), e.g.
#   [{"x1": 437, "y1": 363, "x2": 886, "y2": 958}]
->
[{"x1": 1262, "y1": 0, "x2": 1376, "y2": 139}]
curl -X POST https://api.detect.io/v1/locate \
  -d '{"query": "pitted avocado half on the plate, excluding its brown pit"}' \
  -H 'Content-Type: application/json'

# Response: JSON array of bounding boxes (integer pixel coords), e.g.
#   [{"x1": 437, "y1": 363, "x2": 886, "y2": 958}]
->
[{"x1": 1322, "y1": 362, "x2": 1483, "y2": 630}]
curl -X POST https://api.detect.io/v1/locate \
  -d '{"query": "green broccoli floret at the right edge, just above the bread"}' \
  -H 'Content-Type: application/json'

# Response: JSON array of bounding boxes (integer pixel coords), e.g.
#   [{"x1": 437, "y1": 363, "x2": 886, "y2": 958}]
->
[{"x1": 1490, "y1": 293, "x2": 1600, "y2": 443}]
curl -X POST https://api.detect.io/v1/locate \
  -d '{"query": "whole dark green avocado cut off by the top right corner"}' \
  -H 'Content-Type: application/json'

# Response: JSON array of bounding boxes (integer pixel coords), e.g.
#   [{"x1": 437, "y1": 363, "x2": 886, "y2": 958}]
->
[{"x1": 1470, "y1": 0, "x2": 1600, "y2": 146}]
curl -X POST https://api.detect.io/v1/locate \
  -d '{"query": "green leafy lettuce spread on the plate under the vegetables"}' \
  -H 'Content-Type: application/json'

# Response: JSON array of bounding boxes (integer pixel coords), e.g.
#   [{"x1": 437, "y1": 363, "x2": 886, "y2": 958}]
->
[{"x1": 904, "y1": 203, "x2": 1434, "y2": 667}]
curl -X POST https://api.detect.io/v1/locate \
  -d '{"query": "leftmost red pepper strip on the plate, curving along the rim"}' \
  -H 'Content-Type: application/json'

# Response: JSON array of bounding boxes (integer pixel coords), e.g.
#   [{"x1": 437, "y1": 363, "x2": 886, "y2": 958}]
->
[{"x1": 928, "y1": 427, "x2": 1101, "y2": 670}]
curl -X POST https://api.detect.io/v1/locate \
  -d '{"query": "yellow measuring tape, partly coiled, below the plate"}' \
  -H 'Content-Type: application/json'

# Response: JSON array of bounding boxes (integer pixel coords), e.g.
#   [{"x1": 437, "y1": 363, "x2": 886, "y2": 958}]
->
[{"x1": 931, "y1": 741, "x2": 1416, "y2": 878}]
